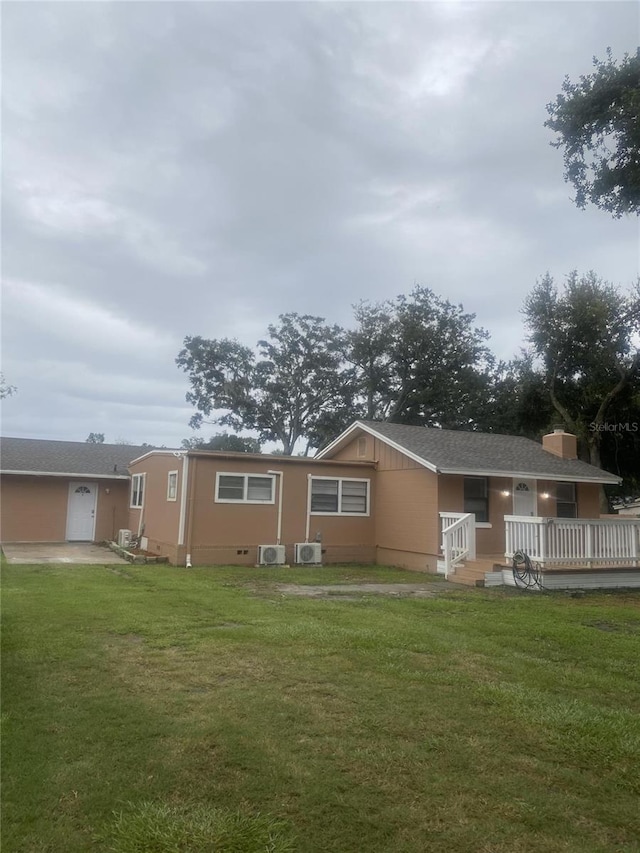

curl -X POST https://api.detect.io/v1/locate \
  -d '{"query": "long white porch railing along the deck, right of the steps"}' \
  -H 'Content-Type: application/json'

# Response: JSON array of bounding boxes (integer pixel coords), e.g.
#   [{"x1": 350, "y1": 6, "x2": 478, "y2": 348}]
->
[{"x1": 504, "y1": 515, "x2": 640, "y2": 568}]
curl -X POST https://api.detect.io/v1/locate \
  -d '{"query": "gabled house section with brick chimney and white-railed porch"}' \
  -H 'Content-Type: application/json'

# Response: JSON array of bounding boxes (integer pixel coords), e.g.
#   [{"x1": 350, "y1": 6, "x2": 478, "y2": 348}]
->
[{"x1": 318, "y1": 421, "x2": 640, "y2": 587}]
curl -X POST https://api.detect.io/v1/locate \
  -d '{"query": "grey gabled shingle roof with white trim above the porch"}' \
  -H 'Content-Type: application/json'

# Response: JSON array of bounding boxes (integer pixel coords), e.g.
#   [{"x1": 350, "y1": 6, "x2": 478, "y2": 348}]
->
[{"x1": 318, "y1": 421, "x2": 620, "y2": 484}]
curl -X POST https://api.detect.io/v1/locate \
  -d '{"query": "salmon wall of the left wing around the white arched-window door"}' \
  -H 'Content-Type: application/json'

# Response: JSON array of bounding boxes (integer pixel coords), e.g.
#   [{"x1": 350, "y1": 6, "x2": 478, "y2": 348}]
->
[{"x1": 0, "y1": 474, "x2": 129, "y2": 542}]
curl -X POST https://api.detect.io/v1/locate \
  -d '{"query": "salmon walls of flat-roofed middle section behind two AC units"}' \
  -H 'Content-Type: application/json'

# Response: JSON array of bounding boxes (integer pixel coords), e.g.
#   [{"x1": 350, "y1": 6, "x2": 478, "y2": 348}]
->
[{"x1": 129, "y1": 454, "x2": 375, "y2": 565}]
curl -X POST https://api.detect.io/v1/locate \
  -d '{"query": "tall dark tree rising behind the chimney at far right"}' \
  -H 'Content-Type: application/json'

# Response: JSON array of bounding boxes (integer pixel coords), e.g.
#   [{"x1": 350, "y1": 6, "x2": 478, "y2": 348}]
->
[{"x1": 524, "y1": 271, "x2": 640, "y2": 476}]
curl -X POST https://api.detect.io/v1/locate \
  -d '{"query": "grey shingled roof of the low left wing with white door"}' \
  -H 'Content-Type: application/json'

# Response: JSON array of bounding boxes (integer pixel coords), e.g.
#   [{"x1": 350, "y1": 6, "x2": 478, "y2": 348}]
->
[{"x1": 0, "y1": 438, "x2": 149, "y2": 480}]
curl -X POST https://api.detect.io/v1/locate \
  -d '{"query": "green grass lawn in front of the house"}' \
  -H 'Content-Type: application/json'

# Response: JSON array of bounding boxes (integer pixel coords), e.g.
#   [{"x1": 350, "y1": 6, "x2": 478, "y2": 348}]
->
[{"x1": 2, "y1": 565, "x2": 640, "y2": 853}]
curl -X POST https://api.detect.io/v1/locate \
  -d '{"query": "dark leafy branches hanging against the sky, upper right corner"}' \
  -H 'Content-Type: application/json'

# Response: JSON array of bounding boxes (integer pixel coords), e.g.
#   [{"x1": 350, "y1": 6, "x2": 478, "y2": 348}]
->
[{"x1": 545, "y1": 48, "x2": 640, "y2": 218}]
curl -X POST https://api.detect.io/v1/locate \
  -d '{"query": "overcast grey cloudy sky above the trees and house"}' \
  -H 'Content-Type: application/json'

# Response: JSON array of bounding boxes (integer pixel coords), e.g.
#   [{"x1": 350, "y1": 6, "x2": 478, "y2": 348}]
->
[{"x1": 2, "y1": 2, "x2": 640, "y2": 446}]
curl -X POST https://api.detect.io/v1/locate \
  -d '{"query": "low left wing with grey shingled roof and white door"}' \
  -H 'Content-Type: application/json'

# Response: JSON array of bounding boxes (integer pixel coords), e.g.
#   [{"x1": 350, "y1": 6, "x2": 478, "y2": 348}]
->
[{"x1": 0, "y1": 438, "x2": 150, "y2": 542}]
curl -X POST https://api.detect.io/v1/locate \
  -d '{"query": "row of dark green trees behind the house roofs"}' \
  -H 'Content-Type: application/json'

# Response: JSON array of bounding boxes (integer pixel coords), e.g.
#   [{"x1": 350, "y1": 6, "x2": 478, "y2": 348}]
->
[{"x1": 176, "y1": 272, "x2": 640, "y2": 488}]
